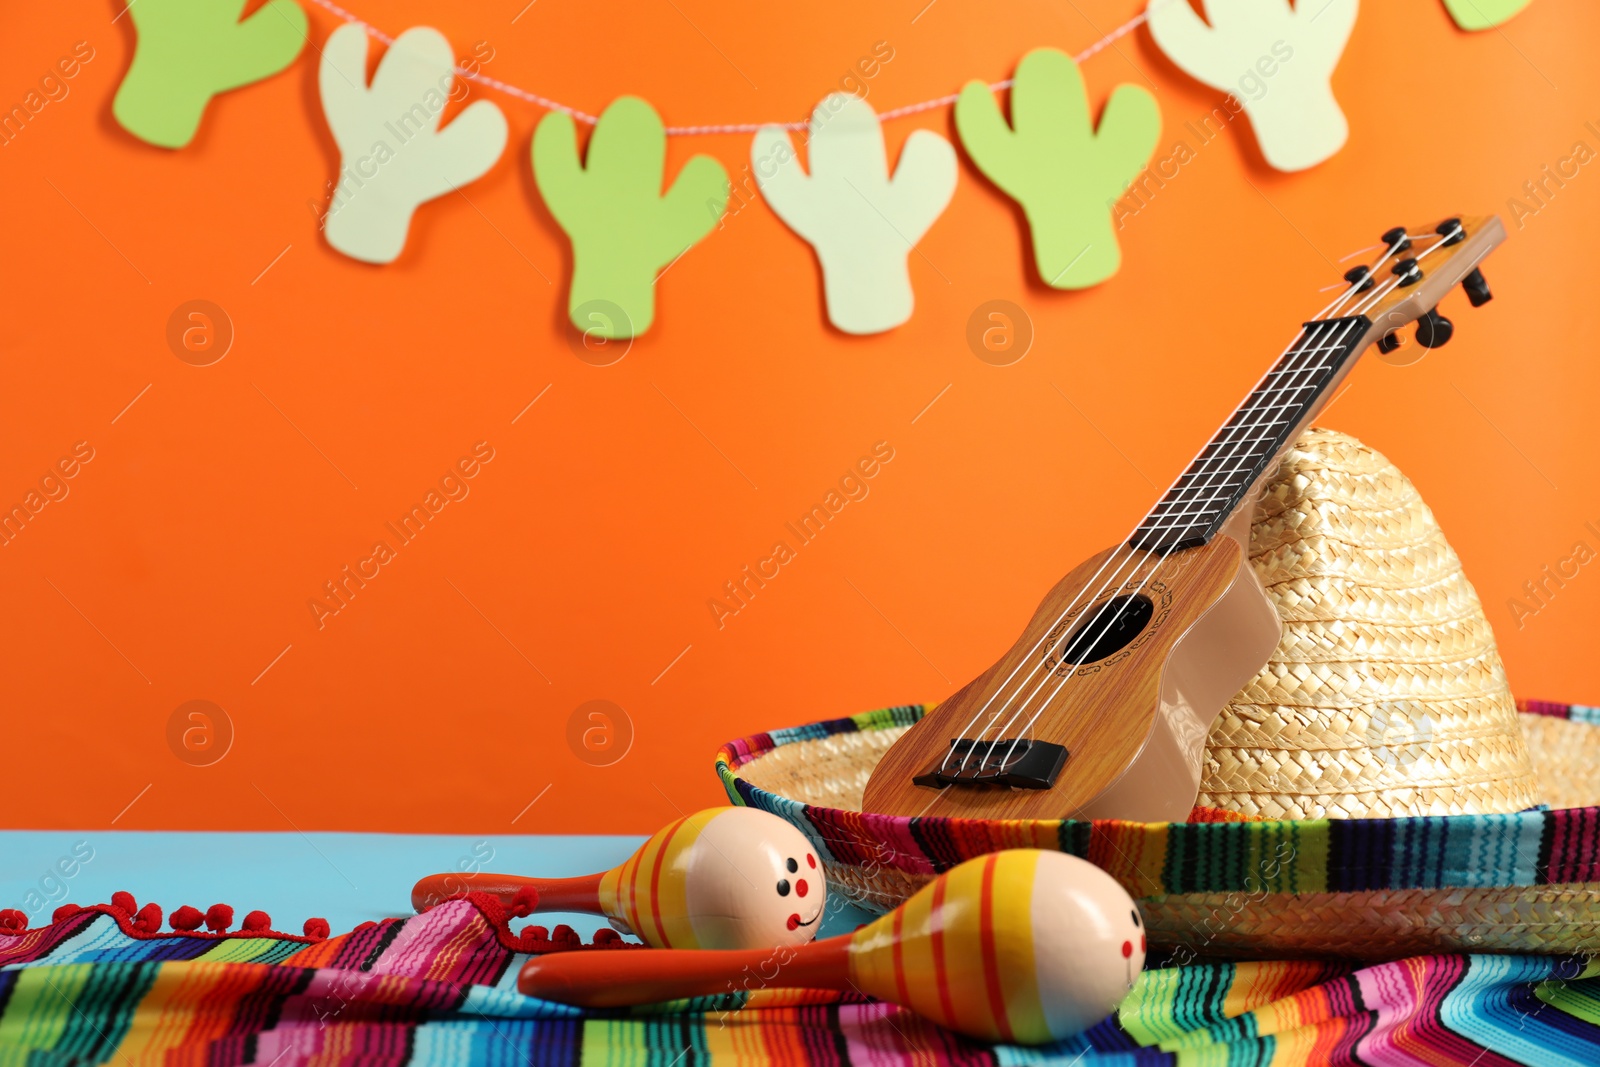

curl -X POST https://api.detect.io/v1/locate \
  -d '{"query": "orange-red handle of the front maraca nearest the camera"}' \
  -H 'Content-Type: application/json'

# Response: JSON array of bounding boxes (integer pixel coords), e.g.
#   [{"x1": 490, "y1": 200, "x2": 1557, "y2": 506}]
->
[{"x1": 517, "y1": 934, "x2": 850, "y2": 1008}]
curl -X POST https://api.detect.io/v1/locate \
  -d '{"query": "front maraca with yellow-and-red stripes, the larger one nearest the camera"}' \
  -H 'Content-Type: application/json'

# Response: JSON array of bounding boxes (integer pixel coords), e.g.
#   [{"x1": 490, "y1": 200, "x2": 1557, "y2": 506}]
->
[{"x1": 517, "y1": 849, "x2": 1144, "y2": 1045}]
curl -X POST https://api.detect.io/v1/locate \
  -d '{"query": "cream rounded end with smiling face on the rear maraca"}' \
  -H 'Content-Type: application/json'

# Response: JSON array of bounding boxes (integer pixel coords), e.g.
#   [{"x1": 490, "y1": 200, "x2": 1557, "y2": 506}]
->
[{"x1": 686, "y1": 808, "x2": 827, "y2": 949}]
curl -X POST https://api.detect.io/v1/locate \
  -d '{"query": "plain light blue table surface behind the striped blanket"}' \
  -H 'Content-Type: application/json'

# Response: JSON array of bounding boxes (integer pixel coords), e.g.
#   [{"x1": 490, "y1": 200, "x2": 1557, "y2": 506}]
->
[{"x1": 0, "y1": 830, "x2": 872, "y2": 941}]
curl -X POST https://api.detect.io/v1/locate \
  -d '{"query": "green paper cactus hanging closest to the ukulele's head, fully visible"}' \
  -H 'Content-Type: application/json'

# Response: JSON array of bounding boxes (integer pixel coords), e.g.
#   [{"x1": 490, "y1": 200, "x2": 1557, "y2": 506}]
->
[{"x1": 955, "y1": 48, "x2": 1162, "y2": 290}]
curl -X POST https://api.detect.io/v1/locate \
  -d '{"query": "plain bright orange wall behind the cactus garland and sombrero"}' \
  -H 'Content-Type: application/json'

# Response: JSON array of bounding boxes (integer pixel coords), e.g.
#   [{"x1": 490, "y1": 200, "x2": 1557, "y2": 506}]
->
[{"x1": 0, "y1": 0, "x2": 1600, "y2": 832}]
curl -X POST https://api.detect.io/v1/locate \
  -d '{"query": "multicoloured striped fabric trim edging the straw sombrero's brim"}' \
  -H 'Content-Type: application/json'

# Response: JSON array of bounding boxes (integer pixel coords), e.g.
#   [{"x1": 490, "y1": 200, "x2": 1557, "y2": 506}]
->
[{"x1": 717, "y1": 704, "x2": 1600, "y2": 897}]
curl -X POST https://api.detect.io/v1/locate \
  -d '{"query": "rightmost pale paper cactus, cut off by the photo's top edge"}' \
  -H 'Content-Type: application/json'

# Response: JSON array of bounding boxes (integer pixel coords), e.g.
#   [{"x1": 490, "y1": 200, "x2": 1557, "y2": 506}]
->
[{"x1": 1146, "y1": 0, "x2": 1356, "y2": 171}]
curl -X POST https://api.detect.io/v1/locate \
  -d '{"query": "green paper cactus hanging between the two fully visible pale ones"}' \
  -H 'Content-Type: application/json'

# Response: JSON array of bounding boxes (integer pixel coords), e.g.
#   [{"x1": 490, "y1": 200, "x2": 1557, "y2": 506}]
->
[{"x1": 533, "y1": 96, "x2": 728, "y2": 341}]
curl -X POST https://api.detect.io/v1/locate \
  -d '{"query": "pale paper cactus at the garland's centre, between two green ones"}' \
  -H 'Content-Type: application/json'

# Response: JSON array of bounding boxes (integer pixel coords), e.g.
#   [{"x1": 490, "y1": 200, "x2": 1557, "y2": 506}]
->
[{"x1": 750, "y1": 93, "x2": 957, "y2": 334}]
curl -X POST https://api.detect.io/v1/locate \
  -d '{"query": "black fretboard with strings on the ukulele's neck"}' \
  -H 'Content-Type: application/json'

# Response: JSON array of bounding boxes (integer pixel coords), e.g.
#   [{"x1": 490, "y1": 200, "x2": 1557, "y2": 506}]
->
[{"x1": 1128, "y1": 315, "x2": 1373, "y2": 555}]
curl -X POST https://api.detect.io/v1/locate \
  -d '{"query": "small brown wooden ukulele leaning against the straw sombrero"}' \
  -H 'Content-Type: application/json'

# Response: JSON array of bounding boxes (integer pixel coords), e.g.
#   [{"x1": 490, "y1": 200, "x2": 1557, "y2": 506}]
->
[{"x1": 862, "y1": 216, "x2": 1506, "y2": 822}]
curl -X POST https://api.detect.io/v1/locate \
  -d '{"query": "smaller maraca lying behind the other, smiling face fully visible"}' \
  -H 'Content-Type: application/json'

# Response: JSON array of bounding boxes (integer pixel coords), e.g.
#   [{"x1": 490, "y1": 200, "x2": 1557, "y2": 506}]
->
[{"x1": 411, "y1": 808, "x2": 827, "y2": 949}]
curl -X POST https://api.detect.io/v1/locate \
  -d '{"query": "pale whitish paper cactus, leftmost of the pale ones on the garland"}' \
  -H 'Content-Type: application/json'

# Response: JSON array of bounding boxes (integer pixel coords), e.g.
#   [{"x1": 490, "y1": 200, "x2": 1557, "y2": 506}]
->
[{"x1": 318, "y1": 24, "x2": 506, "y2": 262}]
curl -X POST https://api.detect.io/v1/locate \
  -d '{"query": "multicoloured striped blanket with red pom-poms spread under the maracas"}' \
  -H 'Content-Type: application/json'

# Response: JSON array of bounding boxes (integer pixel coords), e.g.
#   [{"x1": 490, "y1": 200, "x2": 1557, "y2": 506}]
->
[{"x1": 0, "y1": 894, "x2": 1600, "y2": 1067}]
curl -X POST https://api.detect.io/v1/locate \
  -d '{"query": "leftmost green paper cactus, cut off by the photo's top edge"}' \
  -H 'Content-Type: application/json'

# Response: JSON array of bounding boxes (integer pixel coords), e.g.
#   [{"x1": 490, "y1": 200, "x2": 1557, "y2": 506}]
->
[{"x1": 110, "y1": 0, "x2": 306, "y2": 149}]
